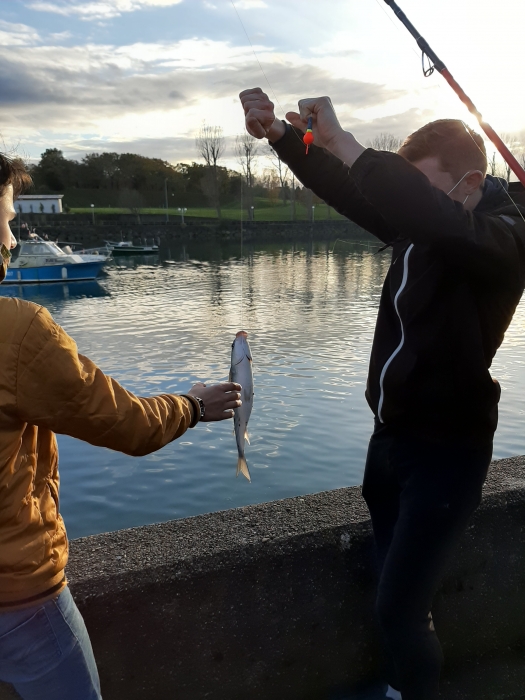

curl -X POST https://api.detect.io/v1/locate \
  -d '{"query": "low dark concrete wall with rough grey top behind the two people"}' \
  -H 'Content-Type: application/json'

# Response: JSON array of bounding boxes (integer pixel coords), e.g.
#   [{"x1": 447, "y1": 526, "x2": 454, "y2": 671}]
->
[{"x1": 0, "y1": 458, "x2": 525, "y2": 700}]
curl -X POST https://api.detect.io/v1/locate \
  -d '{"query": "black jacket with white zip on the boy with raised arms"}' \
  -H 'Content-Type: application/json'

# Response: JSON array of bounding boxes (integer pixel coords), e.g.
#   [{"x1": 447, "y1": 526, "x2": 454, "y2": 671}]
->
[{"x1": 273, "y1": 128, "x2": 525, "y2": 439}]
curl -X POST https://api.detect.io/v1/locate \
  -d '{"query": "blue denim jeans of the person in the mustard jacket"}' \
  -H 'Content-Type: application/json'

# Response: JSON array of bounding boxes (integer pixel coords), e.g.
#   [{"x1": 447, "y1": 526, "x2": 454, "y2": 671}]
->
[{"x1": 0, "y1": 587, "x2": 102, "y2": 700}]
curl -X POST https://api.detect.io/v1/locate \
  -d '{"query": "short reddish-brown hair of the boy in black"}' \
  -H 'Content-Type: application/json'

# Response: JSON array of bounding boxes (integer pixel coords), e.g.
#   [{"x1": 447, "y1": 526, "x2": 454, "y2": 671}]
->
[{"x1": 398, "y1": 119, "x2": 488, "y2": 179}]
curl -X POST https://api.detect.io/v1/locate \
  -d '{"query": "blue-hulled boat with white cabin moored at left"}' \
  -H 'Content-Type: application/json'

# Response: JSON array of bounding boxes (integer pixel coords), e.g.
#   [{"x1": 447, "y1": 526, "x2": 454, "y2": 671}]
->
[{"x1": 4, "y1": 233, "x2": 106, "y2": 284}]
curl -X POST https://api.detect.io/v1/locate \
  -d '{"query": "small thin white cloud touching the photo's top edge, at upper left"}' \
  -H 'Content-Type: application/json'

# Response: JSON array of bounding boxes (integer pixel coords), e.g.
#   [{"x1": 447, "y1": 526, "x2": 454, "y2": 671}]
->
[{"x1": 27, "y1": 0, "x2": 183, "y2": 21}]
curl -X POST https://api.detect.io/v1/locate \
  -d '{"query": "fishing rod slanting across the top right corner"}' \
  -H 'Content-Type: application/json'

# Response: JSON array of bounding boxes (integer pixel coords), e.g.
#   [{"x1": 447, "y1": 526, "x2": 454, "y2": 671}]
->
[{"x1": 385, "y1": 0, "x2": 525, "y2": 187}]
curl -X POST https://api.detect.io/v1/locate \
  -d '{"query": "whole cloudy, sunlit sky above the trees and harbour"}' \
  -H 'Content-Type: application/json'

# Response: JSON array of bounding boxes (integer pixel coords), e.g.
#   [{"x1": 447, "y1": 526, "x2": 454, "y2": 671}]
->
[{"x1": 0, "y1": 0, "x2": 525, "y2": 172}]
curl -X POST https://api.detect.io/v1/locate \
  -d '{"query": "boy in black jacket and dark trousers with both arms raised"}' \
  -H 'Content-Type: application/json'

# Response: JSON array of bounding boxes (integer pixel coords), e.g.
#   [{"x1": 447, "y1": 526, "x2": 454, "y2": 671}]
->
[{"x1": 240, "y1": 88, "x2": 525, "y2": 700}]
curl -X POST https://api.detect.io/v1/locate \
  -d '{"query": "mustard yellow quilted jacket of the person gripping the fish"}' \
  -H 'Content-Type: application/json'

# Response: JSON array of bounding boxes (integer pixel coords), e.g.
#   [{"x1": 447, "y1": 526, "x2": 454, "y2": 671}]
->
[{"x1": 0, "y1": 298, "x2": 192, "y2": 611}]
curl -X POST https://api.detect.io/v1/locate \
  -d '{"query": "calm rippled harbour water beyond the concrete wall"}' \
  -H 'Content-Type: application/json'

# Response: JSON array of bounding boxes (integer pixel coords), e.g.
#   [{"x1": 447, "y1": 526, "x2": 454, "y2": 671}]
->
[{"x1": 1, "y1": 241, "x2": 525, "y2": 537}]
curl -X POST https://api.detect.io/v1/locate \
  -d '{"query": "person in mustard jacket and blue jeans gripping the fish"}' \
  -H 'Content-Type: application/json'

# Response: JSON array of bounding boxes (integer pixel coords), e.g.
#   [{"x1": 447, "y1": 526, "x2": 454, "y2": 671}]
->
[{"x1": 0, "y1": 153, "x2": 241, "y2": 700}]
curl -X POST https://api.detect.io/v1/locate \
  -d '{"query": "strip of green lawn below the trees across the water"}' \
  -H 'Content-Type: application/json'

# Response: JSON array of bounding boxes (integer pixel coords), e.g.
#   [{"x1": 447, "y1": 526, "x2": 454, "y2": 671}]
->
[{"x1": 70, "y1": 200, "x2": 343, "y2": 221}]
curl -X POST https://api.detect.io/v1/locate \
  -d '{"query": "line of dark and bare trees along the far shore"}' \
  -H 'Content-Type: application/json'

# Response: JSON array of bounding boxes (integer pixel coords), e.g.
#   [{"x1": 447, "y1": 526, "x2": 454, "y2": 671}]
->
[{"x1": 26, "y1": 124, "x2": 525, "y2": 218}]
